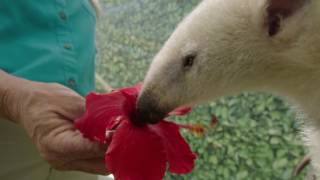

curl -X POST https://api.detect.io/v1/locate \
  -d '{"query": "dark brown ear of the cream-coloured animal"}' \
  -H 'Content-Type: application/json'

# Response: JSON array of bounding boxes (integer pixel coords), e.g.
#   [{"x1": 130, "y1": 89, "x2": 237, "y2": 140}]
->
[{"x1": 266, "y1": 0, "x2": 309, "y2": 36}]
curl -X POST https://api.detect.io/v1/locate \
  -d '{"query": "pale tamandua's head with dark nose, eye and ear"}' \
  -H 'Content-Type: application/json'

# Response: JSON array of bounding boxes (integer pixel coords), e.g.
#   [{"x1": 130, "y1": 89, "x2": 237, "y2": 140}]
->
[{"x1": 137, "y1": 0, "x2": 320, "y2": 123}]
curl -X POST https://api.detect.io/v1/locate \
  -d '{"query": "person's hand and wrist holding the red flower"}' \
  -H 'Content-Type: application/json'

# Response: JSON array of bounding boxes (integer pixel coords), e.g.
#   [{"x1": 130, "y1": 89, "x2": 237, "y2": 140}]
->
[{"x1": 2, "y1": 75, "x2": 107, "y2": 174}]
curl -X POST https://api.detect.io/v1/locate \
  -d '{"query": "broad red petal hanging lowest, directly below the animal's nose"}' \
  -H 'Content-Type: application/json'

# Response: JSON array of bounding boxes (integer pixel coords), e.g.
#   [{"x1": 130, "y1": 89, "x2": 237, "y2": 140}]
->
[{"x1": 105, "y1": 121, "x2": 166, "y2": 180}]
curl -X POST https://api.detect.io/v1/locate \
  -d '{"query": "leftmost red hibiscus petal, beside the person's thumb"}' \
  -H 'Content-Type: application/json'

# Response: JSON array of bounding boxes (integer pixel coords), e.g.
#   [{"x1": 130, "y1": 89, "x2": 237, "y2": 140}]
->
[{"x1": 75, "y1": 91, "x2": 134, "y2": 143}]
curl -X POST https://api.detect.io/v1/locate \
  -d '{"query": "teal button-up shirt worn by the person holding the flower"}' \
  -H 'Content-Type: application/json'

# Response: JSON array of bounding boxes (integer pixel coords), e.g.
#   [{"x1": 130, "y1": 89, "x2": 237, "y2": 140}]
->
[{"x1": 0, "y1": 0, "x2": 96, "y2": 95}]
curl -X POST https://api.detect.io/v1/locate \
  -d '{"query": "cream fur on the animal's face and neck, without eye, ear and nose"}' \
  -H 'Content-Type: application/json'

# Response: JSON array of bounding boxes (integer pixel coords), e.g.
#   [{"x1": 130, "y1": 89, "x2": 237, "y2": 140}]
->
[{"x1": 142, "y1": 0, "x2": 320, "y2": 176}]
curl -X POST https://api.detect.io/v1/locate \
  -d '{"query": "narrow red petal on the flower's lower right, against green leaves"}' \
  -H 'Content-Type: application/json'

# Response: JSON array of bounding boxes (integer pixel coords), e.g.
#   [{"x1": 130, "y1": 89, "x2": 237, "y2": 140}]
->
[{"x1": 148, "y1": 121, "x2": 196, "y2": 174}]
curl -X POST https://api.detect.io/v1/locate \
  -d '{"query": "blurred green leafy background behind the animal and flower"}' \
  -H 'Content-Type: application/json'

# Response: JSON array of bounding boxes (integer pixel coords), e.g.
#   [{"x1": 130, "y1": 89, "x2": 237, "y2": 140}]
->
[{"x1": 97, "y1": 0, "x2": 305, "y2": 180}]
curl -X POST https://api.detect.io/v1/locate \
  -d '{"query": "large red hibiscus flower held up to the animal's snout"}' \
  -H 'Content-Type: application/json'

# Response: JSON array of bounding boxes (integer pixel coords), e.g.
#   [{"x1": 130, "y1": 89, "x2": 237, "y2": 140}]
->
[{"x1": 75, "y1": 85, "x2": 196, "y2": 180}]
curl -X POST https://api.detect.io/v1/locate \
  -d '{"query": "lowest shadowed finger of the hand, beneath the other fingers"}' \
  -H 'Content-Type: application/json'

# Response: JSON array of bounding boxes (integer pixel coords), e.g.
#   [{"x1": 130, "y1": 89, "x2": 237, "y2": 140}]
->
[{"x1": 66, "y1": 158, "x2": 110, "y2": 175}]
